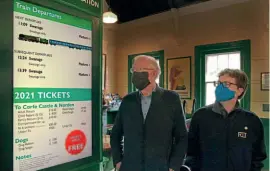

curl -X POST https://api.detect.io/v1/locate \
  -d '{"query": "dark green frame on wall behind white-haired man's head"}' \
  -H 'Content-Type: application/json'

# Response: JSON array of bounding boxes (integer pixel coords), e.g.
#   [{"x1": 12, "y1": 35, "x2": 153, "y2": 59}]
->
[{"x1": 128, "y1": 50, "x2": 164, "y2": 93}]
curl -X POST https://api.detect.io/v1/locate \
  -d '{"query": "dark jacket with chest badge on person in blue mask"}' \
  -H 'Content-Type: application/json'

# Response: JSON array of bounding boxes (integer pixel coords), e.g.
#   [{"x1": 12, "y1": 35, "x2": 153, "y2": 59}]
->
[{"x1": 186, "y1": 103, "x2": 266, "y2": 171}]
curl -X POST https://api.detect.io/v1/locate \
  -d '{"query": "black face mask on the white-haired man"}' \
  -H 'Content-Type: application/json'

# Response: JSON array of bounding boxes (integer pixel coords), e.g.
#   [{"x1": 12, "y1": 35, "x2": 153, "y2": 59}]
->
[{"x1": 132, "y1": 72, "x2": 150, "y2": 90}]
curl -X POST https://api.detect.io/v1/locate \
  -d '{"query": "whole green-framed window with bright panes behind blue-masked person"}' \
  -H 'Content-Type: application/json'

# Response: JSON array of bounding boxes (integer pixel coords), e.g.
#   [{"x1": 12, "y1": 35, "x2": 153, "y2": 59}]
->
[{"x1": 194, "y1": 40, "x2": 251, "y2": 110}]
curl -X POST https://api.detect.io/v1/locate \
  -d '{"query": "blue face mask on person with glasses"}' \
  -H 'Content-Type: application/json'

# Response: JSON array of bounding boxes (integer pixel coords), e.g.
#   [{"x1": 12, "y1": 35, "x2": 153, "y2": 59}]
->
[{"x1": 215, "y1": 84, "x2": 235, "y2": 102}]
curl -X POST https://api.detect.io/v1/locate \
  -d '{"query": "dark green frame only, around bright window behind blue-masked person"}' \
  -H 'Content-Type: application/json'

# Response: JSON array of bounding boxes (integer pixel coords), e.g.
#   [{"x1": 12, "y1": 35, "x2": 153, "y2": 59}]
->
[{"x1": 195, "y1": 40, "x2": 251, "y2": 110}]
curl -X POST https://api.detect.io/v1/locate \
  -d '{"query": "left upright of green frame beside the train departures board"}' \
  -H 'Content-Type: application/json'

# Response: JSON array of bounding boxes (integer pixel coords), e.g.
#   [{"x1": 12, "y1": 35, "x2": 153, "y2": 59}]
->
[{"x1": 0, "y1": 0, "x2": 14, "y2": 171}]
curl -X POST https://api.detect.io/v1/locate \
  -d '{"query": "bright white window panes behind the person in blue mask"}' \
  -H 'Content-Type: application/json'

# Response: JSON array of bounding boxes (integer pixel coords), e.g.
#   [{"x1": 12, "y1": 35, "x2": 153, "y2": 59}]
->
[{"x1": 205, "y1": 52, "x2": 241, "y2": 105}]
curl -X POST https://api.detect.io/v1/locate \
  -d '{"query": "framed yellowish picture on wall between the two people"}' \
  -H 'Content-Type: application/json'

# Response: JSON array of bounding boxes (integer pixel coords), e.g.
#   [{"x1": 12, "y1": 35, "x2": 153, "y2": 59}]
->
[{"x1": 167, "y1": 56, "x2": 191, "y2": 99}]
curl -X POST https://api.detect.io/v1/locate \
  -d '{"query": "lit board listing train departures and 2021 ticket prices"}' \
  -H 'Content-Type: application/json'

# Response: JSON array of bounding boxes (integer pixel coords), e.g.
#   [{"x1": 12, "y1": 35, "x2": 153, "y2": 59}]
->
[{"x1": 13, "y1": 0, "x2": 92, "y2": 171}]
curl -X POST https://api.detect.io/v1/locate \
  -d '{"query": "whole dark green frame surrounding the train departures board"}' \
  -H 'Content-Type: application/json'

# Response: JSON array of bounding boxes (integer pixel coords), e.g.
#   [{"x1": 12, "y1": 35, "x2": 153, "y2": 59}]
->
[{"x1": 0, "y1": 0, "x2": 103, "y2": 171}]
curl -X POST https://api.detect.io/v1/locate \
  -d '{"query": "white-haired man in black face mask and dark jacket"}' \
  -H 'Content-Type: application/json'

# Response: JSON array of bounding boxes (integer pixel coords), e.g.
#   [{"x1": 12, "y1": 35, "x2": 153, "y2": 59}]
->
[{"x1": 111, "y1": 56, "x2": 187, "y2": 171}]
